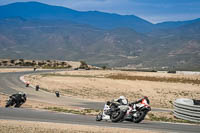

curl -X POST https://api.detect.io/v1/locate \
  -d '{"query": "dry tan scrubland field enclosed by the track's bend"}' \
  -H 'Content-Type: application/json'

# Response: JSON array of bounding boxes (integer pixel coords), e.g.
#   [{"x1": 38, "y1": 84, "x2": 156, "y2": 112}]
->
[{"x1": 25, "y1": 70, "x2": 200, "y2": 108}]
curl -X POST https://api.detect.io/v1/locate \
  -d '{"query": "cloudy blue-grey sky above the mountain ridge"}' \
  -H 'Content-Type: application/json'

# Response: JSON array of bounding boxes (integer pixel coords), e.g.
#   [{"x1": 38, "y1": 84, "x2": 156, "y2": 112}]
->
[{"x1": 0, "y1": 0, "x2": 200, "y2": 23}]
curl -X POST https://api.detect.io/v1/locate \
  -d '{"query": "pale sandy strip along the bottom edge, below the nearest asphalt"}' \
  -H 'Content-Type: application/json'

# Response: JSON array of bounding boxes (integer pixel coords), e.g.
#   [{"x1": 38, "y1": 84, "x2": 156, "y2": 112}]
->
[{"x1": 0, "y1": 120, "x2": 161, "y2": 133}]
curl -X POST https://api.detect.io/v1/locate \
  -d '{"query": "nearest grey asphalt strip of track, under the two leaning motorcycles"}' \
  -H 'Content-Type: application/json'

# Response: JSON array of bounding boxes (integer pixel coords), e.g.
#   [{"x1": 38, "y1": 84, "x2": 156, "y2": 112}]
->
[{"x1": 0, "y1": 108, "x2": 200, "y2": 133}]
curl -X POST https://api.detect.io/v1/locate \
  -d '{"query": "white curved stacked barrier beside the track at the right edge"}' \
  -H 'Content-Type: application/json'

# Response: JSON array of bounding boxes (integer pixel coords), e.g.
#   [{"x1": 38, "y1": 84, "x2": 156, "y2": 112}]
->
[{"x1": 174, "y1": 98, "x2": 200, "y2": 122}]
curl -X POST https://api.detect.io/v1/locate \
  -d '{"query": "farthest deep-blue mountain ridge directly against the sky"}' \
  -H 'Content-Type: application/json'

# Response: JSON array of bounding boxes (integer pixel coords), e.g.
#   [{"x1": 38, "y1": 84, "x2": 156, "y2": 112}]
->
[{"x1": 0, "y1": 2, "x2": 154, "y2": 32}]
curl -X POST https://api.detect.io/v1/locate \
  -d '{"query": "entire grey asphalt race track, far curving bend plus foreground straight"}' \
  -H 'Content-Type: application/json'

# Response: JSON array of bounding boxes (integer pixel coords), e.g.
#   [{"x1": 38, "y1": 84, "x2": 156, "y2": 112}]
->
[{"x1": 0, "y1": 71, "x2": 200, "y2": 133}]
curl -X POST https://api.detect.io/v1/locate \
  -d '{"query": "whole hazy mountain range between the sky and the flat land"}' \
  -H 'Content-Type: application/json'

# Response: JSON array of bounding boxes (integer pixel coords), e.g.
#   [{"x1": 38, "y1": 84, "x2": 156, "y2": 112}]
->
[{"x1": 0, "y1": 2, "x2": 200, "y2": 70}]
